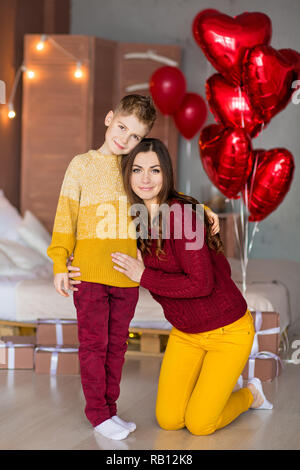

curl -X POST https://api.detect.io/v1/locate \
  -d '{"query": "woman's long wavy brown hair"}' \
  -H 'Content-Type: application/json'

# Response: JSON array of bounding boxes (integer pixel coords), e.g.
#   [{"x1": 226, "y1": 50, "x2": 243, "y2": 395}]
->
[{"x1": 121, "y1": 138, "x2": 224, "y2": 256}]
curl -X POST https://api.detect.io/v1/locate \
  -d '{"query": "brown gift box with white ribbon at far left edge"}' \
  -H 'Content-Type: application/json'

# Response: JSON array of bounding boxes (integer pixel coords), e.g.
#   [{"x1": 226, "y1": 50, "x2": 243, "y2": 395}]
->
[{"x1": 0, "y1": 336, "x2": 35, "y2": 369}]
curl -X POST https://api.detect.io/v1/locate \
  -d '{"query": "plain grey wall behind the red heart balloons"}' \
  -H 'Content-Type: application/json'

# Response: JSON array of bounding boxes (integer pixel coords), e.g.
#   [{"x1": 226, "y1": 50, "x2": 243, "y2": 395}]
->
[{"x1": 71, "y1": 0, "x2": 300, "y2": 261}]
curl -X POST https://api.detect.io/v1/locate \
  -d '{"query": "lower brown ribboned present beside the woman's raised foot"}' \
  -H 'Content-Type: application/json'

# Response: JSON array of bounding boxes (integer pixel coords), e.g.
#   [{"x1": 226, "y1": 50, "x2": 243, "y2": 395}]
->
[{"x1": 242, "y1": 351, "x2": 283, "y2": 382}]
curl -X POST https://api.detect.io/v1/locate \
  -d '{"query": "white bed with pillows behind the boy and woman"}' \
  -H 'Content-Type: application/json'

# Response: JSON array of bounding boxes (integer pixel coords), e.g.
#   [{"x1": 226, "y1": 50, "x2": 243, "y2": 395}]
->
[{"x1": 0, "y1": 191, "x2": 300, "y2": 346}]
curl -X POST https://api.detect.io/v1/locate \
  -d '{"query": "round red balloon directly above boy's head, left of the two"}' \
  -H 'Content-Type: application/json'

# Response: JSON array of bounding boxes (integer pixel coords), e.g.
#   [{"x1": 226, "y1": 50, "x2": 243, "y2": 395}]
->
[{"x1": 150, "y1": 65, "x2": 186, "y2": 115}]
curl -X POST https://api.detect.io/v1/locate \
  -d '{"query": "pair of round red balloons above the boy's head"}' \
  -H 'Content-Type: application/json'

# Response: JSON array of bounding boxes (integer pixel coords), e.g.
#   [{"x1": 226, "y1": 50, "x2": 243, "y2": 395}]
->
[{"x1": 150, "y1": 65, "x2": 207, "y2": 140}]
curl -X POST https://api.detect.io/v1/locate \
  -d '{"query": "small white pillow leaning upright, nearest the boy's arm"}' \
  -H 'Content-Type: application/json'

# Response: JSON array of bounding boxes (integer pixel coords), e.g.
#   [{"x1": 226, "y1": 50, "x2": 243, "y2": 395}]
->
[{"x1": 18, "y1": 210, "x2": 51, "y2": 262}]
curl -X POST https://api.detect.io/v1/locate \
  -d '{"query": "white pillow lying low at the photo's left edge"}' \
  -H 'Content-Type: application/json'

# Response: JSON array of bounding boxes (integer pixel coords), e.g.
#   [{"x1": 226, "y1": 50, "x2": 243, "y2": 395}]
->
[{"x1": 0, "y1": 239, "x2": 46, "y2": 270}]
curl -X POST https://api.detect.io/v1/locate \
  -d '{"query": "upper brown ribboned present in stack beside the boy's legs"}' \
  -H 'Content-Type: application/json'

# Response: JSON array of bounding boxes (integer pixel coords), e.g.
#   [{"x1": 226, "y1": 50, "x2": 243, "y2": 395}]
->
[{"x1": 36, "y1": 318, "x2": 79, "y2": 346}]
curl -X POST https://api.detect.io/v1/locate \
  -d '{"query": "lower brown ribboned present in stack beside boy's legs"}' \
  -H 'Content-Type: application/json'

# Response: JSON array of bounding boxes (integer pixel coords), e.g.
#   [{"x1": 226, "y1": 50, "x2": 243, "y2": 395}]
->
[{"x1": 34, "y1": 346, "x2": 79, "y2": 375}]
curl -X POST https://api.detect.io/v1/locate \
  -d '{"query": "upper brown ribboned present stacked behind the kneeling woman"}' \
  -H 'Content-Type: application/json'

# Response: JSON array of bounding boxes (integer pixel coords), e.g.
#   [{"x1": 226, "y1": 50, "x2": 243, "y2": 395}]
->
[{"x1": 251, "y1": 310, "x2": 280, "y2": 355}]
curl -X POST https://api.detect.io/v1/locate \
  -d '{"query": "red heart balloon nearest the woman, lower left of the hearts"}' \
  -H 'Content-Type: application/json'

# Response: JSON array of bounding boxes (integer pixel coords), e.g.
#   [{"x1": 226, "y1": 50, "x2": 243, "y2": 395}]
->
[{"x1": 199, "y1": 124, "x2": 252, "y2": 198}]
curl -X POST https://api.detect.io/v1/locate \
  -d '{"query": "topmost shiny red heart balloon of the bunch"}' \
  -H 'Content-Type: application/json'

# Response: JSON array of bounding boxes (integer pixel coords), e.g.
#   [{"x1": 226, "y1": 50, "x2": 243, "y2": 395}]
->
[{"x1": 192, "y1": 10, "x2": 272, "y2": 85}]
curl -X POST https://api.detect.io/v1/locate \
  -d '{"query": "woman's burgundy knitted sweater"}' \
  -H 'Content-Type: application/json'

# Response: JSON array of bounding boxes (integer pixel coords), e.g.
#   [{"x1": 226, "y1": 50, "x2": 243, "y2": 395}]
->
[{"x1": 140, "y1": 201, "x2": 247, "y2": 333}]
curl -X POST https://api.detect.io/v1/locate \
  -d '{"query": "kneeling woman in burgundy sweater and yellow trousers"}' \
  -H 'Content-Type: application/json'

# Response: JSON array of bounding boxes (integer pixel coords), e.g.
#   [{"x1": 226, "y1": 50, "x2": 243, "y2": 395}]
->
[{"x1": 69, "y1": 139, "x2": 272, "y2": 435}]
